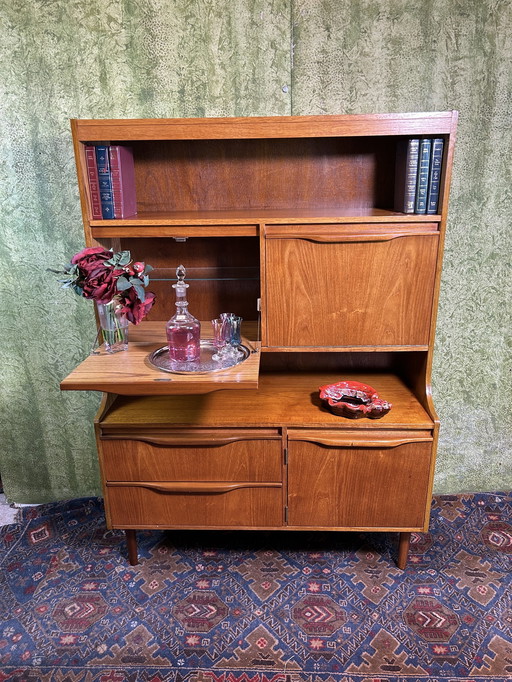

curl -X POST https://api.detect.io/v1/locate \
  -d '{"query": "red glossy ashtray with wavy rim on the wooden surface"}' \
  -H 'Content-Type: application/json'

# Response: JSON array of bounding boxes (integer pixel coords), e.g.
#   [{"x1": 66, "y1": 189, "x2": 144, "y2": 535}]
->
[{"x1": 319, "y1": 381, "x2": 392, "y2": 419}]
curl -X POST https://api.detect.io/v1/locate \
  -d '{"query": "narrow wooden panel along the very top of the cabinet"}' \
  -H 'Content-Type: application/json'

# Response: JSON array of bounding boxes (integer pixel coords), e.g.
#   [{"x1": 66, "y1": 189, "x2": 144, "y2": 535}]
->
[{"x1": 71, "y1": 111, "x2": 458, "y2": 142}]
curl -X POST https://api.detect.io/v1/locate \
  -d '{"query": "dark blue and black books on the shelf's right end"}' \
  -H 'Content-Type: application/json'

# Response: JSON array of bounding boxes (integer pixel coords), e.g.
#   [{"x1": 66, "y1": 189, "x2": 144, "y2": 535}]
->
[{"x1": 395, "y1": 137, "x2": 444, "y2": 214}]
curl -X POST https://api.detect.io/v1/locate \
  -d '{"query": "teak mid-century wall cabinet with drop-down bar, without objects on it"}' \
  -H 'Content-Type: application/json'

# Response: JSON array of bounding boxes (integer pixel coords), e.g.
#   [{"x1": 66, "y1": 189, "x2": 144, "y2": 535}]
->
[{"x1": 61, "y1": 112, "x2": 457, "y2": 568}]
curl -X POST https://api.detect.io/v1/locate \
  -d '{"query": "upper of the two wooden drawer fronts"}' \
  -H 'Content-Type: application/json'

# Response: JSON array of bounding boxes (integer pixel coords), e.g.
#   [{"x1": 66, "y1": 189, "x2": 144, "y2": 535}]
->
[{"x1": 102, "y1": 432, "x2": 282, "y2": 482}]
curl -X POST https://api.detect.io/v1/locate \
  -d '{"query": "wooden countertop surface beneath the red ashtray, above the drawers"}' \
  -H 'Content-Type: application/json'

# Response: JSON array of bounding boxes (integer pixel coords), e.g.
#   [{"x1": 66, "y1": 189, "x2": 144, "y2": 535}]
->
[{"x1": 101, "y1": 371, "x2": 434, "y2": 434}]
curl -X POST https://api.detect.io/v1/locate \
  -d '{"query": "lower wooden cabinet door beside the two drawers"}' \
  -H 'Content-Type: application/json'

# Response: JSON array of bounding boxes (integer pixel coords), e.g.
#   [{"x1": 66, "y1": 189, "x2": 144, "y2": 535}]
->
[{"x1": 288, "y1": 430, "x2": 433, "y2": 530}]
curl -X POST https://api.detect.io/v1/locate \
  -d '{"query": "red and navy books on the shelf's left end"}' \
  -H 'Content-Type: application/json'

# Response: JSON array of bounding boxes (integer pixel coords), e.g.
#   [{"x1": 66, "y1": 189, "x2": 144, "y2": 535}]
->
[{"x1": 85, "y1": 145, "x2": 137, "y2": 220}]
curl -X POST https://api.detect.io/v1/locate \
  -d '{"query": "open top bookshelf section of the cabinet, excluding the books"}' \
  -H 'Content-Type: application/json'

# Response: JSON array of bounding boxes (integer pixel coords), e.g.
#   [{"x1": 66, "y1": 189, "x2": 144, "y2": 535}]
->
[{"x1": 72, "y1": 112, "x2": 456, "y2": 230}]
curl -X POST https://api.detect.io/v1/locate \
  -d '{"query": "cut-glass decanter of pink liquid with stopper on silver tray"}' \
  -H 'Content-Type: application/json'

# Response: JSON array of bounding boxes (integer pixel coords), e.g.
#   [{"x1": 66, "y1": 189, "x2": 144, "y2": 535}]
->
[{"x1": 166, "y1": 265, "x2": 201, "y2": 362}]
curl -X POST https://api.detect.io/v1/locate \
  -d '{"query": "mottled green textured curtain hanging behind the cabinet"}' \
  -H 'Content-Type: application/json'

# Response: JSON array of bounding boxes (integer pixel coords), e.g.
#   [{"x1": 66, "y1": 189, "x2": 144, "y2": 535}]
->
[{"x1": 0, "y1": 0, "x2": 512, "y2": 502}]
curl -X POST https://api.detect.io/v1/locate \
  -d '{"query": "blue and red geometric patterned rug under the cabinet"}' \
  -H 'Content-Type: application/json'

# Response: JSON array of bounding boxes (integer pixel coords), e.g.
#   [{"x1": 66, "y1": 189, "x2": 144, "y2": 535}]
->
[{"x1": 0, "y1": 493, "x2": 512, "y2": 682}]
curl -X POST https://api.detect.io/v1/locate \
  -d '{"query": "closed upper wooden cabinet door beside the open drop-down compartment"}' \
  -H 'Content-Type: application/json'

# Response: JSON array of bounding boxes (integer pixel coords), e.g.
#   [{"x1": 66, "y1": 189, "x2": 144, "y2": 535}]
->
[{"x1": 264, "y1": 225, "x2": 438, "y2": 347}]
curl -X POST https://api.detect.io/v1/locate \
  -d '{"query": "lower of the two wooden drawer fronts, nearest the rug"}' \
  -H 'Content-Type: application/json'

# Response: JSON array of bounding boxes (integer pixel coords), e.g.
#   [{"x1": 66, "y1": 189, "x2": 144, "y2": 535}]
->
[{"x1": 106, "y1": 483, "x2": 283, "y2": 528}]
